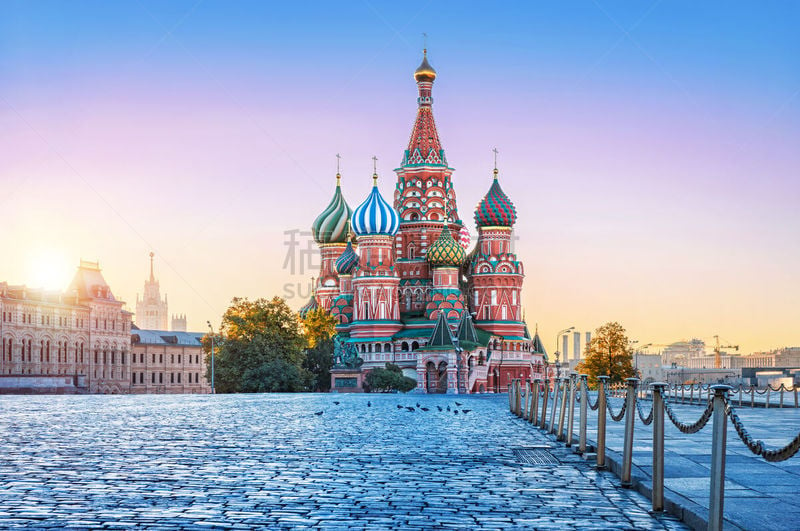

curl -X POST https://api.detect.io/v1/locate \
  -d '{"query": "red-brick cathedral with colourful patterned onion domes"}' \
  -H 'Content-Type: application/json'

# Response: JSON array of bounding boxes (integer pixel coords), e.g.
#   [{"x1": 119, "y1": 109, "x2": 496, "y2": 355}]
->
[{"x1": 300, "y1": 51, "x2": 547, "y2": 393}]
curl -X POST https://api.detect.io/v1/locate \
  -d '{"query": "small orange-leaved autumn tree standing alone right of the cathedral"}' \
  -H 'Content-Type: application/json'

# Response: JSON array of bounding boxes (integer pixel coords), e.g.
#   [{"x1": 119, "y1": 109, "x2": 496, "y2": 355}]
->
[{"x1": 577, "y1": 322, "x2": 635, "y2": 388}]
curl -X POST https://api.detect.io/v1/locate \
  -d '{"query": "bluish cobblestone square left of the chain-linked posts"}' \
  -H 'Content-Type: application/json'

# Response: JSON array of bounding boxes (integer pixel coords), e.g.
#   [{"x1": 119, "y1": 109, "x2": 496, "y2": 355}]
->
[{"x1": 0, "y1": 394, "x2": 683, "y2": 530}]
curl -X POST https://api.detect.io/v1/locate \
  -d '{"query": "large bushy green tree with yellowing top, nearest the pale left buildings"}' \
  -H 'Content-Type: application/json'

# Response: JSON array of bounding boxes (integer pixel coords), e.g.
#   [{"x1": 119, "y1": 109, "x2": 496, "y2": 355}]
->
[{"x1": 203, "y1": 297, "x2": 311, "y2": 393}]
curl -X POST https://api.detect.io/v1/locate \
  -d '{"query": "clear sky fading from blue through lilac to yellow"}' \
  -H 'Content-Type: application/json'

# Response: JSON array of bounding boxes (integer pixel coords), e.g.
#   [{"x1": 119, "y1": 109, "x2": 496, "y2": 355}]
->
[{"x1": 0, "y1": 0, "x2": 800, "y2": 353}]
